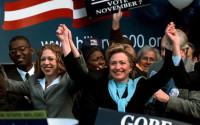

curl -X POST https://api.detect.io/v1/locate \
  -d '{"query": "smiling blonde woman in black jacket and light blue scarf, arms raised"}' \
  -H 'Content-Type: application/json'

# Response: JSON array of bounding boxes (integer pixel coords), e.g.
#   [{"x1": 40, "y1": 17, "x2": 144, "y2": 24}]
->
[{"x1": 57, "y1": 25, "x2": 180, "y2": 125}]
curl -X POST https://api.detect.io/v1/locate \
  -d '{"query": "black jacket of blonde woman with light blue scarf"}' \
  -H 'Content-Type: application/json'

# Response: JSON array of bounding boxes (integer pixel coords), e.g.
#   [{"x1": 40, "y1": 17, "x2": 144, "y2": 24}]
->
[{"x1": 68, "y1": 48, "x2": 173, "y2": 125}]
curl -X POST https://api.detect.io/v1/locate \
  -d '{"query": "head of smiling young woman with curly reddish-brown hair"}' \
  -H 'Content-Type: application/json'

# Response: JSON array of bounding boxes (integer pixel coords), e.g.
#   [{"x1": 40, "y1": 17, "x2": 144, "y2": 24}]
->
[{"x1": 35, "y1": 43, "x2": 66, "y2": 78}]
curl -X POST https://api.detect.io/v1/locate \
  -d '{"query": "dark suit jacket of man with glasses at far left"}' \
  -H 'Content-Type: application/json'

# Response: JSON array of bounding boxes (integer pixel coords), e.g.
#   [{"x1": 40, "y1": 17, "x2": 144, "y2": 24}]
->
[{"x1": 0, "y1": 68, "x2": 33, "y2": 111}]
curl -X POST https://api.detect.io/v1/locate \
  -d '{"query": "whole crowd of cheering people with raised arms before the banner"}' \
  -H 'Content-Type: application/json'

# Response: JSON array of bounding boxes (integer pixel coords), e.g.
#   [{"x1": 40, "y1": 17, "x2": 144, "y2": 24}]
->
[{"x1": 0, "y1": 9, "x2": 200, "y2": 125}]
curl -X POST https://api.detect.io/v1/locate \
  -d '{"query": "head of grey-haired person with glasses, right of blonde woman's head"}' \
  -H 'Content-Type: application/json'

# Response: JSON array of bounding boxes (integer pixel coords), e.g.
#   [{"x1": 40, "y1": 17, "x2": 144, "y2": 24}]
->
[{"x1": 137, "y1": 45, "x2": 161, "y2": 73}]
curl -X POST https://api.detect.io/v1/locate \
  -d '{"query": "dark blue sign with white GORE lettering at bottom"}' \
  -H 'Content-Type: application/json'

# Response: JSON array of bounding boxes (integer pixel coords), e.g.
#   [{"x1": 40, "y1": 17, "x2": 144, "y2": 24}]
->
[{"x1": 95, "y1": 108, "x2": 189, "y2": 125}]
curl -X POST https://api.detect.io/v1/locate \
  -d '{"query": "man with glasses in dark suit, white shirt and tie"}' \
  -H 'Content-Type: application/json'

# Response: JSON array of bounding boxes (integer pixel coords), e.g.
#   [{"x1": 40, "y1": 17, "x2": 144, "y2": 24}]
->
[{"x1": 0, "y1": 36, "x2": 35, "y2": 111}]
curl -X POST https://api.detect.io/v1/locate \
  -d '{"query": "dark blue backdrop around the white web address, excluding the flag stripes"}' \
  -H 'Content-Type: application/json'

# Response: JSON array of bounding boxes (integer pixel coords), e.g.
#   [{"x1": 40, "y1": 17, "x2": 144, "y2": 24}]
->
[{"x1": 0, "y1": 0, "x2": 198, "y2": 63}]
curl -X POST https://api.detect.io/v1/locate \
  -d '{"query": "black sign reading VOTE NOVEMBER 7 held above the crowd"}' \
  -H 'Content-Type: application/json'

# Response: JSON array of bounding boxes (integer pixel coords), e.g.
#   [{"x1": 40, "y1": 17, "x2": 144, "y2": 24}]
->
[{"x1": 84, "y1": 0, "x2": 150, "y2": 18}]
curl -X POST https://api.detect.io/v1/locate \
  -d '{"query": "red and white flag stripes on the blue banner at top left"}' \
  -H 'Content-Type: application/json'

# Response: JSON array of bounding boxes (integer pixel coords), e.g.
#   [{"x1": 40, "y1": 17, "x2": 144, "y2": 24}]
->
[{"x1": 2, "y1": 0, "x2": 130, "y2": 30}]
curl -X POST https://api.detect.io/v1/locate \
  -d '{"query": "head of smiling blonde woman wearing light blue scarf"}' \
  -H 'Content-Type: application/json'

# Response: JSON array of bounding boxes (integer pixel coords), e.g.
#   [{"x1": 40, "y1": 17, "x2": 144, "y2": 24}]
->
[{"x1": 105, "y1": 43, "x2": 136, "y2": 83}]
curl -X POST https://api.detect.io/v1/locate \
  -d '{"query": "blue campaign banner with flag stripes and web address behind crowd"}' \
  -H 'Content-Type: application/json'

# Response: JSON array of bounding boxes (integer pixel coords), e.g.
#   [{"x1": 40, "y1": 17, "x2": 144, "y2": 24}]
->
[{"x1": 0, "y1": 0, "x2": 168, "y2": 63}]
